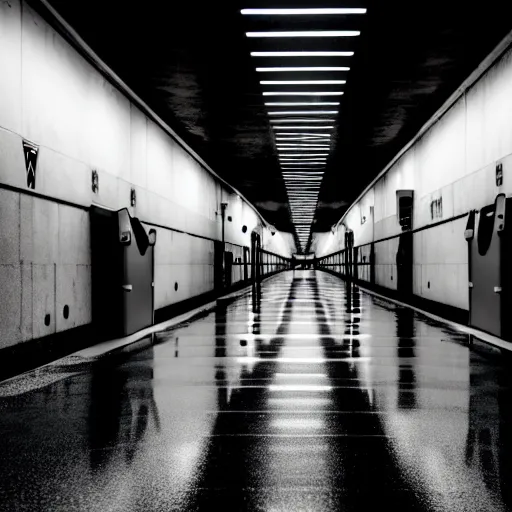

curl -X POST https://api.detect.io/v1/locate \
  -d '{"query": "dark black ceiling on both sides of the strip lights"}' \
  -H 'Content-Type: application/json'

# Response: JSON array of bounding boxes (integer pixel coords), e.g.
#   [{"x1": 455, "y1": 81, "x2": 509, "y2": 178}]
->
[{"x1": 31, "y1": 0, "x2": 512, "y2": 250}]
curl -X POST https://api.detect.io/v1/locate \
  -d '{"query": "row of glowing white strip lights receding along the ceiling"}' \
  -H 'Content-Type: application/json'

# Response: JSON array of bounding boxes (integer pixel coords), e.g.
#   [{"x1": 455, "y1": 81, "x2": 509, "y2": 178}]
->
[{"x1": 242, "y1": 4, "x2": 366, "y2": 252}]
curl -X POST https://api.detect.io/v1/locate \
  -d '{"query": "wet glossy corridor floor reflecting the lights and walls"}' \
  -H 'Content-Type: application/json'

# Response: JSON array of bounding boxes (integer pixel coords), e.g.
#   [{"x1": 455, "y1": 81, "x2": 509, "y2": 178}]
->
[{"x1": 0, "y1": 271, "x2": 512, "y2": 512}]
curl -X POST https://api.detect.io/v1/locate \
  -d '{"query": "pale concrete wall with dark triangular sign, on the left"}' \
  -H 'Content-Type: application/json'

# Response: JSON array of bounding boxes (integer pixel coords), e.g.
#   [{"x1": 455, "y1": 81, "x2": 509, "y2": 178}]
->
[{"x1": 0, "y1": 0, "x2": 295, "y2": 348}]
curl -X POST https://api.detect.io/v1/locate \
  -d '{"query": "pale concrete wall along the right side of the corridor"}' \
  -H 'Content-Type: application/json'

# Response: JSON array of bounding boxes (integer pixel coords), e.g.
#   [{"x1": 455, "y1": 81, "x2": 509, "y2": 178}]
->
[{"x1": 313, "y1": 39, "x2": 512, "y2": 309}]
